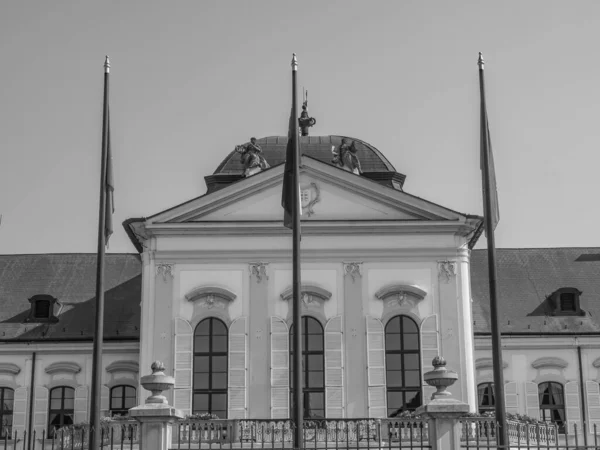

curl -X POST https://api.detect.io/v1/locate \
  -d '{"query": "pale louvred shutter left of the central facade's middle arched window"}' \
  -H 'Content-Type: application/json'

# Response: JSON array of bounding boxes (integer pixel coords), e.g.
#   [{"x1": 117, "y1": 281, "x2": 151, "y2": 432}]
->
[{"x1": 271, "y1": 316, "x2": 290, "y2": 419}]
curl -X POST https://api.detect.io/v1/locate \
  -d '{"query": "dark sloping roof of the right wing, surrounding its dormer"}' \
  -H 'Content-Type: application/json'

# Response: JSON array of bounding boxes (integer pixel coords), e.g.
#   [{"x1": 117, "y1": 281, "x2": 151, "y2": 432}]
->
[{"x1": 471, "y1": 247, "x2": 600, "y2": 334}]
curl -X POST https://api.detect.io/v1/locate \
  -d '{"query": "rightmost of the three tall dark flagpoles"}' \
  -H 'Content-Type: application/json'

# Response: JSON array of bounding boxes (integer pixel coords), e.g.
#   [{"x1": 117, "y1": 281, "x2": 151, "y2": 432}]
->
[{"x1": 478, "y1": 53, "x2": 508, "y2": 448}]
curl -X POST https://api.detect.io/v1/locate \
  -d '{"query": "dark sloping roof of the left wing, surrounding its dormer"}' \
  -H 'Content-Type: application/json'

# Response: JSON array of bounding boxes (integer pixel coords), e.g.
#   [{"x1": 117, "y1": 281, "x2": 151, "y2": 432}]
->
[{"x1": 0, "y1": 253, "x2": 141, "y2": 340}]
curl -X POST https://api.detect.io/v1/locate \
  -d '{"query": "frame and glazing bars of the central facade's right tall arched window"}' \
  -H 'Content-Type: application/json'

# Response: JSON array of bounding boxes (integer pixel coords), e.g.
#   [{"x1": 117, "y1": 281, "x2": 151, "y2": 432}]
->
[{"x1": 384, "y1": 314, "x2": 423, "y2": 417}]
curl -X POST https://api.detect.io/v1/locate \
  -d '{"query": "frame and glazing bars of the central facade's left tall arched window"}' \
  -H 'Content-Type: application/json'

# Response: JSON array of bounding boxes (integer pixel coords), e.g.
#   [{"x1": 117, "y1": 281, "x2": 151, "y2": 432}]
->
[{"x1": 192, "y1": 317, "x2": 229, "y2": 419}]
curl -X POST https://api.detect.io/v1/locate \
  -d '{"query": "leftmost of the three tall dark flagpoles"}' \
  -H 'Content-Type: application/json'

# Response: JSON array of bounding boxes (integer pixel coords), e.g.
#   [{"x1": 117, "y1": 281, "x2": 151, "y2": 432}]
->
[{"x1": 89, "y1": 56, "x2": 110, "y2": 450}]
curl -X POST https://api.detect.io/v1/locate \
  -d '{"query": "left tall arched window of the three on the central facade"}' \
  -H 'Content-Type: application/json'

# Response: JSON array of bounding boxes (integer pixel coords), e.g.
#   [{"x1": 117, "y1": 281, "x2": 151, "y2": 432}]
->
[{"x1": 192, "y1": 317, "x2": 227, "y2": 419}]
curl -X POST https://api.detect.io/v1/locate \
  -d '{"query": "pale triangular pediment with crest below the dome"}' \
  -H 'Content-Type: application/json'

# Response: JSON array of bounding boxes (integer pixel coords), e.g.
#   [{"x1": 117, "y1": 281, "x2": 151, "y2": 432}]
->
[{"x1": 147, "y1": 157, "x2": 466, "y2": 225}]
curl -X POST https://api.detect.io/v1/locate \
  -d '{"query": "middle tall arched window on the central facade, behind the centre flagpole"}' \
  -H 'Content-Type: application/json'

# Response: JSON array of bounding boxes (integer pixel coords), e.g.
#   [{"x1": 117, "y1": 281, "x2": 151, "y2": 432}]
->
[{"x1": 290, "y1": 316, "x2": 325, "y2": 419}]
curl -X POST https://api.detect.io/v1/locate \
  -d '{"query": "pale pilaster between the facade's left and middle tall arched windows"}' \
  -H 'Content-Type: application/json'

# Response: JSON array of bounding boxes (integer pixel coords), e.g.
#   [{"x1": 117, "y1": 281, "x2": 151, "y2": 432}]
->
[{"x1": 248, "y1": 262, "x2": 271, "y2": 419}]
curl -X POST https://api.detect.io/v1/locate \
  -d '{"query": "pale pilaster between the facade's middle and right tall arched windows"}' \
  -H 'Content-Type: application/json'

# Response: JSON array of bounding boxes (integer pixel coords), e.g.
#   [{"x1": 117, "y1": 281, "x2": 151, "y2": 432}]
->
[{"x1": 343, "y1": 261, "x2": 369, "y2": 418}]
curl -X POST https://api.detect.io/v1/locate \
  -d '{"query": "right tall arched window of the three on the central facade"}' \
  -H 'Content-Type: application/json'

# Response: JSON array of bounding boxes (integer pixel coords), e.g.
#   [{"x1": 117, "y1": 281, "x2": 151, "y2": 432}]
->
[{"x1": 385, "y1": 316, "x2": 421, "y2": 417}]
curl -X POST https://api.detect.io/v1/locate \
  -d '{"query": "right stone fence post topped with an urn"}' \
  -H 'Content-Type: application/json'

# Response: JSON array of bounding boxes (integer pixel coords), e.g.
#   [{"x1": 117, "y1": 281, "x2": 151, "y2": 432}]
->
[{"x1": 416, "y1": 356, "x2": 469, "y2": 450}]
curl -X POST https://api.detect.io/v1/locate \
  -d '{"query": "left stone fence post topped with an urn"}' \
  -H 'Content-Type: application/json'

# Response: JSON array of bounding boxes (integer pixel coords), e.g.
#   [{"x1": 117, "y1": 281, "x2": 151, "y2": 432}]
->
[{"x1": 129, "y1": 361, "x2": 183, "y2": 450}]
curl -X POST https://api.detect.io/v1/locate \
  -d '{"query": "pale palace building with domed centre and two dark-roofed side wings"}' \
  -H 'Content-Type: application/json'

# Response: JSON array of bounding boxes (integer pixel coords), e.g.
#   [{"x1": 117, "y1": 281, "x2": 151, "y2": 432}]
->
[{"x1": 0, "y1": 136, "x2": 600, "y2": 438}]
